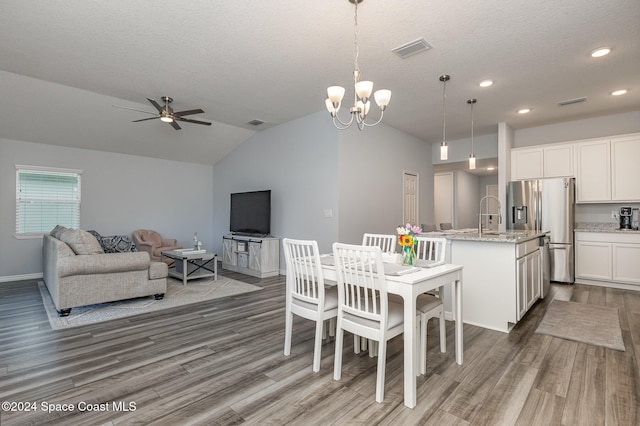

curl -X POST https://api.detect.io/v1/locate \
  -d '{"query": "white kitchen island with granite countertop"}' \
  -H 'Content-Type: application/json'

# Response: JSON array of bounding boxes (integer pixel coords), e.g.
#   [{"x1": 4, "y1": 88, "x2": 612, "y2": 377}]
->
[{"x1": 424, "y1": 230, "x2": 546, "y2": 333}]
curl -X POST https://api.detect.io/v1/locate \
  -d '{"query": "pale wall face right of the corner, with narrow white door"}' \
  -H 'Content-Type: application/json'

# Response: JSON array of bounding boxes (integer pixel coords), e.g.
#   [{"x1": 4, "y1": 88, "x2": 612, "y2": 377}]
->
[{"x1": 338, "y1": 124, "x2": 434, "y2": 244}]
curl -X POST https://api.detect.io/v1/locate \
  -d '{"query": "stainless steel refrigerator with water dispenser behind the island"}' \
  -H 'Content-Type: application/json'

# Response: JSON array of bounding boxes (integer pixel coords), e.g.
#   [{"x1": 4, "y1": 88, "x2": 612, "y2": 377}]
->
[{"x1": 506, "y1": 178, "x2": 575, "y2": 283}]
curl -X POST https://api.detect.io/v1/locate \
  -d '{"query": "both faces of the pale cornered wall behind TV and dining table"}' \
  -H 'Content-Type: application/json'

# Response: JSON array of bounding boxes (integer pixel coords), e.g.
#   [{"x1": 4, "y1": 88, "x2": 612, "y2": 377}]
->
[{"x1": 213, "y1": 112, "x2": 433, "y2": 269}]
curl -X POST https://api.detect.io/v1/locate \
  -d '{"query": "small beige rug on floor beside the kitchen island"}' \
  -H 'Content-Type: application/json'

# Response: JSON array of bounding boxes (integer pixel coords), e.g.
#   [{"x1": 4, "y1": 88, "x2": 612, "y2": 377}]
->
[{"x1": 536, "y1": 300, "x2": 625, "y2": 351}]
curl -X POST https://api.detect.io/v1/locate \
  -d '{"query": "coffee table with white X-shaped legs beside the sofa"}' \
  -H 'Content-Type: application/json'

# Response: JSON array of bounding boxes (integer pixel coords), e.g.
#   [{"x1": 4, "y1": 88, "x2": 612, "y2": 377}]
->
[{"x1": 161, "y1": 250, "x2": 218, "y2": 285}]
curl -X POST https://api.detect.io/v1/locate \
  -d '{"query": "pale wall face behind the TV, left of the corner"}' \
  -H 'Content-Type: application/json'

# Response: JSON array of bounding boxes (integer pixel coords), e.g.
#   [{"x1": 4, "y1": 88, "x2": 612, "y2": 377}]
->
[{"x1": 213, "y1": 112, "x2": 339, "y2": 258}]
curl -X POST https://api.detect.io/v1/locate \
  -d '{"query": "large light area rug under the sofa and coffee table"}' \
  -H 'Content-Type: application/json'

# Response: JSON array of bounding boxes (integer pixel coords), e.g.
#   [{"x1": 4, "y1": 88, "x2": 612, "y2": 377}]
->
[{"x1": 38, "y1": 276, "x2": 262, "y2": 330}]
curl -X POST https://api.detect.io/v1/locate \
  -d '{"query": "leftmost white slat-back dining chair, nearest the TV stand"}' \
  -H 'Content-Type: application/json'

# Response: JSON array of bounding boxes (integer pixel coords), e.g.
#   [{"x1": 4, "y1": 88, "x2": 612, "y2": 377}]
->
[{"x1": 282, "y1": 238, "x2": 338, "y2": 372}]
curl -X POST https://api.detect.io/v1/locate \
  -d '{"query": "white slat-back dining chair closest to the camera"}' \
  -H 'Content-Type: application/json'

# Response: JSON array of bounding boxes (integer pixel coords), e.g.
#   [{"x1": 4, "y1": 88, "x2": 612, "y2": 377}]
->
[{"x1": 333, "y1": 243, "x2": 404, "y2": 402}]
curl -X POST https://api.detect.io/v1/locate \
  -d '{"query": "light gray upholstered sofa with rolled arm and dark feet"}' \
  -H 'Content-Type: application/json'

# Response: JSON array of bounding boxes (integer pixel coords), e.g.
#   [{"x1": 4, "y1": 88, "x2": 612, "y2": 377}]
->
[{"x1": 42, "y1": 226, "x2": 168, "y2": 316}]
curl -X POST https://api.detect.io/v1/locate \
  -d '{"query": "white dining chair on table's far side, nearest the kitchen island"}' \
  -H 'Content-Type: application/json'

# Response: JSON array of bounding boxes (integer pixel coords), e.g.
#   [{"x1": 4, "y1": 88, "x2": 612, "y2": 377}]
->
[{"x1": 416, "y1": 236, "x2": 447, "y2": 374}]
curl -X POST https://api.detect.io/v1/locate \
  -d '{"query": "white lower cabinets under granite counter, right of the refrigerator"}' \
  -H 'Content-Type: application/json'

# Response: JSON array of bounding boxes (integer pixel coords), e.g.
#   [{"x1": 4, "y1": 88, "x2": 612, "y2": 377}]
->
[{"x1": 575, "y1": 232, "x2": 640, "y2": 285}]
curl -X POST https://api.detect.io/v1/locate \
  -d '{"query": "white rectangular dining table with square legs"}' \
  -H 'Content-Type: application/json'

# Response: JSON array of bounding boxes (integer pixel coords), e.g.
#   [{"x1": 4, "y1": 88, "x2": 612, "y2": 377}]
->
[{"x1": 322, "y1": 255, "x2": 464, "y2": 408}]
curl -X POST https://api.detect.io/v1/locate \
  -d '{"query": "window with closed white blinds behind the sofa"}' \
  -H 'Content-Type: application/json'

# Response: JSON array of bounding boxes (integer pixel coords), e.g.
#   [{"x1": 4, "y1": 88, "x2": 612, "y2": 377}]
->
[{"x1": 16, "y1": 164, "x2": 82, "y2": 238}]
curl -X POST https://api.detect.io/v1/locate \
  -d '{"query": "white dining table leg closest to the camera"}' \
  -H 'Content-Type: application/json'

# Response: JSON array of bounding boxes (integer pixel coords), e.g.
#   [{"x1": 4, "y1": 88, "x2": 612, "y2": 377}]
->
[{"x1": 403, "y1": 291, "x2": 418, "y2": 408}]
